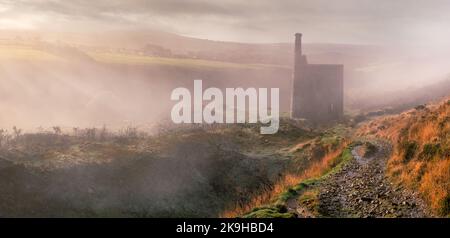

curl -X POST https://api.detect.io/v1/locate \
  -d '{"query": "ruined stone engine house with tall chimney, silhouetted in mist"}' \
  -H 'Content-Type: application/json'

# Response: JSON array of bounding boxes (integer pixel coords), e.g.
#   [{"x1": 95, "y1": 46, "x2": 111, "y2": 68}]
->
[{"x1": 291, "y1": 33, "x2": 344, "y2": 123}]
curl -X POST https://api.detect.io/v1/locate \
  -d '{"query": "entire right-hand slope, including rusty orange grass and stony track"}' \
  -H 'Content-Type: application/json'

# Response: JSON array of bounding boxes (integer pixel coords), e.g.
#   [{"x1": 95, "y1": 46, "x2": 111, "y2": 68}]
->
[{"x1": 234, "y1": 100, "x2": 450, "y2": 218}]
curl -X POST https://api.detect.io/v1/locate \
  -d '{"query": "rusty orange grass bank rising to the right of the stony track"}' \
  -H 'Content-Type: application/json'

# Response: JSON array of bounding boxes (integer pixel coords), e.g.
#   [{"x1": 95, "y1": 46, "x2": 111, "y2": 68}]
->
[{"x1": 359, "y1": 100, "x2": 450, "y2": 216}]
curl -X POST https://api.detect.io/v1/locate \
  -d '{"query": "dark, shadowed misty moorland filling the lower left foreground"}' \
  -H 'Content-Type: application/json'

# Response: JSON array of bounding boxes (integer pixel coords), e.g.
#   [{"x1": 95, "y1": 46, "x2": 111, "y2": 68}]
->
[{"x1": 0, "y1": 119, "x2": 352, "y2": 217}]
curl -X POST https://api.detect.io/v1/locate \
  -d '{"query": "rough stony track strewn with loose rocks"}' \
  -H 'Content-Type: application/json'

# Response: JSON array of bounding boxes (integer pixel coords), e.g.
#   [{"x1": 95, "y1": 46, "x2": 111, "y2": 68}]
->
[{"x1": 295, "y1": 142, "x2": 431, "y2": 218}]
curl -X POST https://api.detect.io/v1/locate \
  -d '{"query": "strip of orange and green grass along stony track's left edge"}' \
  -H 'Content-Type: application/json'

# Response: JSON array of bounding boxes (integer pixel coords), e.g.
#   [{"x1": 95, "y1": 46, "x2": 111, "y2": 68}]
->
[{"x1": 222, "y1": 125, "x2": 351, "y2": 218}]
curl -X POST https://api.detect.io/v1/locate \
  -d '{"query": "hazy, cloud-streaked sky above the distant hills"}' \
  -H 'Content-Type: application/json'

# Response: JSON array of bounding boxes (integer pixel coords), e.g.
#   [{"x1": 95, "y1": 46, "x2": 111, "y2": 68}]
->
[{"x1": 0, "y1": 0, "x2": 450, "y2": 45}]
